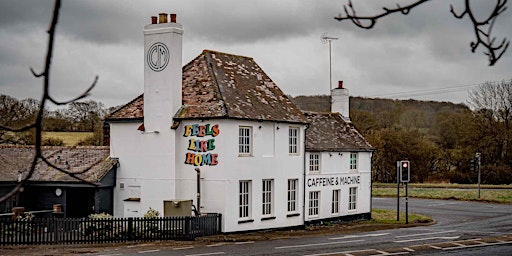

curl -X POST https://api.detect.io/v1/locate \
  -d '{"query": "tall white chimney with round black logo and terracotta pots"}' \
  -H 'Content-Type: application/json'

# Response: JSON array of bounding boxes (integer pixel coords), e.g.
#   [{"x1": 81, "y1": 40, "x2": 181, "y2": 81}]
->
[{"x1": 144, "y1": 13, "x2": 183, "y2": 132}]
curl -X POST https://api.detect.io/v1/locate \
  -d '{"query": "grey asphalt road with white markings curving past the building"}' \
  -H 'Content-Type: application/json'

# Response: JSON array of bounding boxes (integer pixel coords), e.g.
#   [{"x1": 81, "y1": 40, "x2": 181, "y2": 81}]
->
[{"x1": 89, "y1": 198, "x2": 512, "y2": 256}]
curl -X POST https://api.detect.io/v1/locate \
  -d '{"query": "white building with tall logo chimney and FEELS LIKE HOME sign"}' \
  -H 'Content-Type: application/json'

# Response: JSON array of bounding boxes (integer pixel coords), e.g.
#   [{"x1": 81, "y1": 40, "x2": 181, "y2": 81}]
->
[{"x1": 106, "y1": 15, "x2": 371, "y2": 232}]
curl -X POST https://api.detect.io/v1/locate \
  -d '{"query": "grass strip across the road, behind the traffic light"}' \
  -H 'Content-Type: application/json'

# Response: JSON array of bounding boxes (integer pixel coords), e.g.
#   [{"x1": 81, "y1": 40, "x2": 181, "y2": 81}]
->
[{"x1": 372, "y1": 183, "x2": 512, "y2": 204}]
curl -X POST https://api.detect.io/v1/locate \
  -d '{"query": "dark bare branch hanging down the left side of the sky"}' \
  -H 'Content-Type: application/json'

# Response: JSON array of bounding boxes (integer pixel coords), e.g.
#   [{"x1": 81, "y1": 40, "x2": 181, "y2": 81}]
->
[{"x1": 0, "y1": 0, "x2": 98, "y2": 203}]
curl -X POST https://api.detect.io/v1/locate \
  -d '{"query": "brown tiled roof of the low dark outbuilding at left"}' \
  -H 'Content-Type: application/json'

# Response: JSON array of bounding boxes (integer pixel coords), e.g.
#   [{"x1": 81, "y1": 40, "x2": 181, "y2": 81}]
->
[{"x1": 0, "y1": 145, "x2": 117, "y2": 183}]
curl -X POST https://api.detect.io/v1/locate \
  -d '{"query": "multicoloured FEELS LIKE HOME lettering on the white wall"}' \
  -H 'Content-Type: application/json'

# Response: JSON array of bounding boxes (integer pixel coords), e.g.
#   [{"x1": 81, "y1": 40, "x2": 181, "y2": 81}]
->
[{"x1": 183, "y1": 124, "x2": 220, "y2": 166}]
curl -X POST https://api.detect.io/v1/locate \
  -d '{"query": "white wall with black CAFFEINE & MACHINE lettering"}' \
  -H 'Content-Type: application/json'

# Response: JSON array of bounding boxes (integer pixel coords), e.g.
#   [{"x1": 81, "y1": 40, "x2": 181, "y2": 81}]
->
[{"x1": 305, "y1": 152, "x2": 371, "y2": 221}]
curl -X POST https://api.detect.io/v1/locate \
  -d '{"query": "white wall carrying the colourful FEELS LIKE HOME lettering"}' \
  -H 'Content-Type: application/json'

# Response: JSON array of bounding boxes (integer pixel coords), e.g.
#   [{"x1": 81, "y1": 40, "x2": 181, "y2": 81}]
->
[{"x1": 176, "y1": 120, "x2": 304, "y2": 232}]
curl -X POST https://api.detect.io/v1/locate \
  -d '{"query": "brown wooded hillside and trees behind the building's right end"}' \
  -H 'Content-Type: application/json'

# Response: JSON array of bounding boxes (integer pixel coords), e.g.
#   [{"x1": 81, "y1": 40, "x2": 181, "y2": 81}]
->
[{"x1": 292, "y1": 80, "x2": 512, "y2": 184}]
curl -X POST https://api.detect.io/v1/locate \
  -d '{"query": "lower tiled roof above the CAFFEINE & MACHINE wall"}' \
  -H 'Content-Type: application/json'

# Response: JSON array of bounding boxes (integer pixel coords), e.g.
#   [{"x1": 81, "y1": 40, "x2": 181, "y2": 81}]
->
[{"x1": 303, "y1": 112, "x2": 373, "y2": 152}]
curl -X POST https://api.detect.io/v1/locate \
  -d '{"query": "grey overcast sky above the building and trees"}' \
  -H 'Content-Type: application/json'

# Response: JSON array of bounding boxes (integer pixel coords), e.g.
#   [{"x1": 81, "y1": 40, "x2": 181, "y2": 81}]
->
[{"x1": 0, "y1": 0, "x2": 512, "y2": 106}]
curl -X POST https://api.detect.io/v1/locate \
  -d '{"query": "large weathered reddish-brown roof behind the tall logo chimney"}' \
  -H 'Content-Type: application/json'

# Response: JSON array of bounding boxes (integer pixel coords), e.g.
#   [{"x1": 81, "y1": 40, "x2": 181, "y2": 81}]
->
[{"x1": 107, "y1": 50, "x2": 307, "y2": 123}]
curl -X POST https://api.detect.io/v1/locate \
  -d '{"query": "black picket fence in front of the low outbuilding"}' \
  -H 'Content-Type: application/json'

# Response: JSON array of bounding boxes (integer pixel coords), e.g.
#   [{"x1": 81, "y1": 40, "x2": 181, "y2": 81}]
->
[{"x1": 0, "y1": 213, "x2": 221, "y2": 245}]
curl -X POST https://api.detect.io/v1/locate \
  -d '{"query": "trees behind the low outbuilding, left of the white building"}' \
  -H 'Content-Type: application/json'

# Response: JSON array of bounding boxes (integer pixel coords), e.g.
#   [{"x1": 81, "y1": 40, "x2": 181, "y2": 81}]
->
[{"x1": 0, "y1": 94, "x2": 114, "y2": 146}]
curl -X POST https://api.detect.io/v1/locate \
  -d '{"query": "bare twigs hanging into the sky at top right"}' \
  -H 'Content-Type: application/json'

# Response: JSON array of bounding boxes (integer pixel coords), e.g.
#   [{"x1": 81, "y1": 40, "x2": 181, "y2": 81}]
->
[{"x1": 335, "y1": 0, "x2": 510, "y2": 66}]
